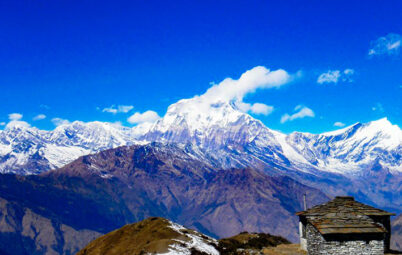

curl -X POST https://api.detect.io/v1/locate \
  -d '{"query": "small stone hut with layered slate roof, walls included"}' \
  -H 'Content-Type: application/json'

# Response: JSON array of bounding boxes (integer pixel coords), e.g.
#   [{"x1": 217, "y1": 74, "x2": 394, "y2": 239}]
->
[{"x1": 296, "y1": 196, "x2": 395, "y2": 255}]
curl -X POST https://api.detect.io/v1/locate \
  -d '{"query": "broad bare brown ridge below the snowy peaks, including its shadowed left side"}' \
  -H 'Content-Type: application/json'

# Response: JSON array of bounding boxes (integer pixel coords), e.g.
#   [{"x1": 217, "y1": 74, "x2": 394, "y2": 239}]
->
[{"x1": 0, "y1": 144, "x2": 329, "y2": 254}]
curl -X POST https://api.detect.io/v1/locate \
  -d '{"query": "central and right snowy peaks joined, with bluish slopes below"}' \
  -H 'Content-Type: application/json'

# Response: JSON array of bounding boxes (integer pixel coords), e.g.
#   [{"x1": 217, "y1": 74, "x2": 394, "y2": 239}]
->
[{"x1": 139, "y1": 97, "x2": 402, "y2": 212}]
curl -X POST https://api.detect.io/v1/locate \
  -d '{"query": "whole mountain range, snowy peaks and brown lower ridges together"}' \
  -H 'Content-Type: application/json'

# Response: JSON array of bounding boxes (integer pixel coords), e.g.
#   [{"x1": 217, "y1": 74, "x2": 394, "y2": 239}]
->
[{"x1": 0, "y1": 97, "x2": 402, "y2": 254}]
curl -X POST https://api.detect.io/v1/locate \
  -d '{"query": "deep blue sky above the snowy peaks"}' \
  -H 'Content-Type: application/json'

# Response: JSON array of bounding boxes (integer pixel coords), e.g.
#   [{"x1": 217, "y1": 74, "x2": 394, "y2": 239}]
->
[{"x1": 0, "y1": 1, "x2": 402, "y2": 133}]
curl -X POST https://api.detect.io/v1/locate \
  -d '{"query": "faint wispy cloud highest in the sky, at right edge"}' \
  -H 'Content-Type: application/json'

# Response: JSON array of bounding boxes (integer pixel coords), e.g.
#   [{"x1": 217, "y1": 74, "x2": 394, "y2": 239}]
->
[{"x1": 368, "y1": 33, "x2": 402, "y2": 56}]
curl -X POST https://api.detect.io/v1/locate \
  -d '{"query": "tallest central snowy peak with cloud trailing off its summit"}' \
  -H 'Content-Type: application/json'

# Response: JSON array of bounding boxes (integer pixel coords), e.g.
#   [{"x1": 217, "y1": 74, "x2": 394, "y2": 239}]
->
[{"x1": 140, "y1": 97, "x2": 308, "y2": 171}]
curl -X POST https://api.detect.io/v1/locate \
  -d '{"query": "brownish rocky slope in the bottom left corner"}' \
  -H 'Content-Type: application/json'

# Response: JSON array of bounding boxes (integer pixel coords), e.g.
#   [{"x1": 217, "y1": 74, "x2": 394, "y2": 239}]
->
[{"x1": 0, "y1": 187, "x2": 101, "y2": 255}]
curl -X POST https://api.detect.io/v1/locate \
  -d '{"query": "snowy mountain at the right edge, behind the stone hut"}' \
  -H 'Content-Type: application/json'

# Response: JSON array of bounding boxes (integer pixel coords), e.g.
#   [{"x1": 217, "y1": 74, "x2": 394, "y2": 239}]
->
[{"x1": 286, "y1": 118, "x2": 402, "y2": 174}]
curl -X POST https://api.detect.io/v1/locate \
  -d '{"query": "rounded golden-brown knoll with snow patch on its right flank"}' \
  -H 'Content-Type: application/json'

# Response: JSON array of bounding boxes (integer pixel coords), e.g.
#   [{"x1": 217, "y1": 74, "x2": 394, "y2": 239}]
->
[{"x1": 77, "y1": 217, "x2": 219, "y2": 255}]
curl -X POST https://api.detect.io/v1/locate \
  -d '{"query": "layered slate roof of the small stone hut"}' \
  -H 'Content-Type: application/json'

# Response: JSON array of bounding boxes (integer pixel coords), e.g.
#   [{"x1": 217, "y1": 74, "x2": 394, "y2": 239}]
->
[{"x1": 296, "y1": 197, "x2": 395, "y2": 235}]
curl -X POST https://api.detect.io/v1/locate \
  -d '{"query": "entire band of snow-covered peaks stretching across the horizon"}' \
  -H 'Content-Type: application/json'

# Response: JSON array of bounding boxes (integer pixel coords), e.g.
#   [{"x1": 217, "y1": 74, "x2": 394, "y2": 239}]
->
[{"x1": 0, "y1": 96, "x2": 402, "y2": 175}]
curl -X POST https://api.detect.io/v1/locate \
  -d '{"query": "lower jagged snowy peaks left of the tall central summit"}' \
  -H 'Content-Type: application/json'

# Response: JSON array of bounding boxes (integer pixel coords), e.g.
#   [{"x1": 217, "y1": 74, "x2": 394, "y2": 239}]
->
[{"x1": 0, "y1": 121, "x2": 144, "y2": 175}]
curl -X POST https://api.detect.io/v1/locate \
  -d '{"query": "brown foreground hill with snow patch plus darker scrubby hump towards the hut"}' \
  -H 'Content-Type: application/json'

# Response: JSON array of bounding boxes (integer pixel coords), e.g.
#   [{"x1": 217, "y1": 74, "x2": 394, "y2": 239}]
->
[{"x1": 77, "y1": 217, "x2": 289, "y2": 255}]
